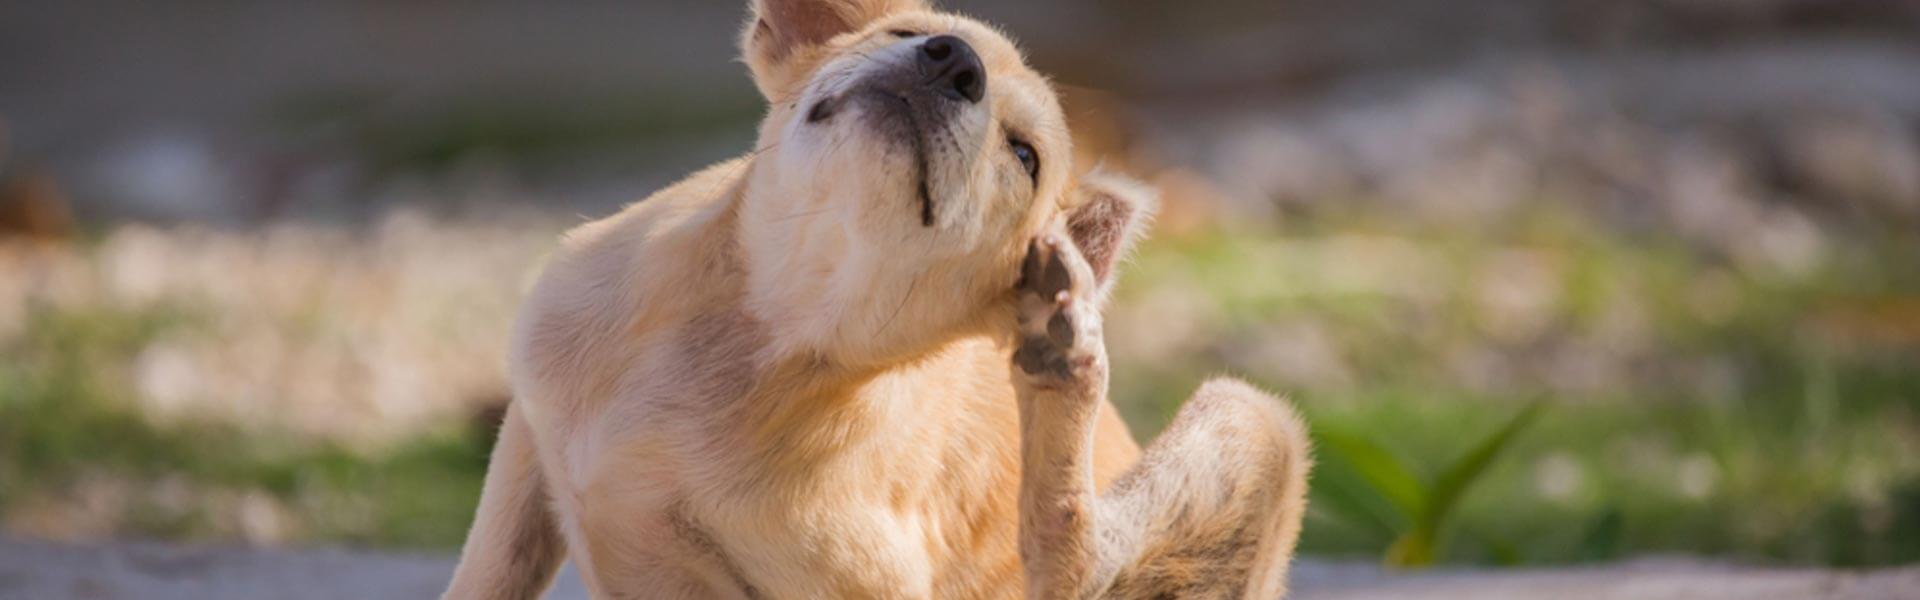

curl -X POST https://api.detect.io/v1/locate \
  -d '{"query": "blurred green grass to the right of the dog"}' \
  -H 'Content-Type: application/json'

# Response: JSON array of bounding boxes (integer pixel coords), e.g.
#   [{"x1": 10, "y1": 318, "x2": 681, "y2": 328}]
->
[{"x1": 1110, "y1": 205, "x2": 1920, "y2": 565}]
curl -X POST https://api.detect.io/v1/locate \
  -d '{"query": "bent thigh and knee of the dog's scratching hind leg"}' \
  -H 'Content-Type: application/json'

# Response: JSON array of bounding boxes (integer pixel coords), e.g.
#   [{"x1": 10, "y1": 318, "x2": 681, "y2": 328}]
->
[{"x1": 1100, "y1": 379, "x2": 1309, "y2": 598}]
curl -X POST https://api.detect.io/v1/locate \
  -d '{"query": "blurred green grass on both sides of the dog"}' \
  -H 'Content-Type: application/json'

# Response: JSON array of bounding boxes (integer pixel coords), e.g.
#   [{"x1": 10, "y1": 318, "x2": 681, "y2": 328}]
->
[{"x1": 0, "y1": 202, "x2": 1920, "y2": 565}]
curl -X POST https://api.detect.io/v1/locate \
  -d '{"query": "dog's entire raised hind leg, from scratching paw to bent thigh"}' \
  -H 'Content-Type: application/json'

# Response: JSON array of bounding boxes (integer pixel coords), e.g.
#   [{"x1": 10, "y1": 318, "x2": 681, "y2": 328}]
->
[{"x1": 1014, "y1": 238, "x2": 1309, "y2": 598}]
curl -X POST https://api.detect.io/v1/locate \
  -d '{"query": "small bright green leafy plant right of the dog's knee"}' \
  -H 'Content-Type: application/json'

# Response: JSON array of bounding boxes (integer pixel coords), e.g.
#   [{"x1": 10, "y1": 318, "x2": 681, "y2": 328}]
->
[{"x1": 1315, "y1": 402, "x2": 1546, "y2": 567}]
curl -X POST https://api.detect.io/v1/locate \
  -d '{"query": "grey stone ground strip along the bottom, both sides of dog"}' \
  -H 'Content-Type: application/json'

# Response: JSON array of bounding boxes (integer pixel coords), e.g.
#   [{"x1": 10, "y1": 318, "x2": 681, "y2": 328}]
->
[{"x1": 0, "y1": 538, "x2": 1920, "y2": 600}]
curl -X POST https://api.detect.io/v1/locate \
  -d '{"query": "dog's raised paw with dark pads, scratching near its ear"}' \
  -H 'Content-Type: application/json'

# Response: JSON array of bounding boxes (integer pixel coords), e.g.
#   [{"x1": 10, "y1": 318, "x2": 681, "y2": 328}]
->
[{"x1": 1014, "y1": 233, "x2": 1106, "y2": 388}]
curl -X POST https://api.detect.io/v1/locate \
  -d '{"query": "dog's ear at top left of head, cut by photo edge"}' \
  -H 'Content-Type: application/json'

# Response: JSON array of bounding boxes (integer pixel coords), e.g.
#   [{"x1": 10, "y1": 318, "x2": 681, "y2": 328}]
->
[{"x1": 739, "y1": 0, "x2": 925, "y2": 102}]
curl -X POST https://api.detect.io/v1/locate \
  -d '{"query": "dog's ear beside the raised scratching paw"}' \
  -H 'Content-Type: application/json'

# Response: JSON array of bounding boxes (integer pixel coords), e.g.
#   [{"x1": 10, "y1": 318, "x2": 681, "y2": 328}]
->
[{"x1": 1066, "y1": 169, "x2": 1160, "y2": 302}]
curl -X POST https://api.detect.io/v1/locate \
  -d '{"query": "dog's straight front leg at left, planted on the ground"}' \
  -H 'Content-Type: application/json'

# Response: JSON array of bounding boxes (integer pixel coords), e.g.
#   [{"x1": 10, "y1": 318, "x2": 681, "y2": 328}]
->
[{"x1": 442, "y1": 402, "x2": 566, "y2": 600}]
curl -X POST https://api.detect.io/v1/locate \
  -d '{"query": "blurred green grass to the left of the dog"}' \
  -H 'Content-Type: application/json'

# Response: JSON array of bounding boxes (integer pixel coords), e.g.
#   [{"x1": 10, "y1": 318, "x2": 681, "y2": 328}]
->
[{"x1": 0, "y1": 306, "x2": 490, "y2": 548}]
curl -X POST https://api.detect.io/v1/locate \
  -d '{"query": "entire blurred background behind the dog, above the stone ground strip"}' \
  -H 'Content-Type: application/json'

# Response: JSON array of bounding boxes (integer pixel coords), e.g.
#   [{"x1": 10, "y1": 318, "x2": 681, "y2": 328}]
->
[{"x1": 0, "y1": 0, "x2": 1920, "y2": 565}]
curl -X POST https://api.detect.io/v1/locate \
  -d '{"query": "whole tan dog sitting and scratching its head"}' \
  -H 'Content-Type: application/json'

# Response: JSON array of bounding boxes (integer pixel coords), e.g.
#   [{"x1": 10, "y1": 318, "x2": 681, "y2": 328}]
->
[{"x1": 447, "y1": 0, "x2": 1308, "y2": 598}]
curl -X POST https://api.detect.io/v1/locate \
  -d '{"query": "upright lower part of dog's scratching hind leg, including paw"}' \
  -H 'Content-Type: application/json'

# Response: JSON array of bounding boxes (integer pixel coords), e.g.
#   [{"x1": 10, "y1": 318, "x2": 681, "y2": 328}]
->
[{"x1": 1014, "y1": 235, "x2": 1131, "y2": 598}]
